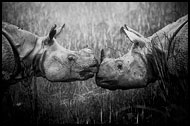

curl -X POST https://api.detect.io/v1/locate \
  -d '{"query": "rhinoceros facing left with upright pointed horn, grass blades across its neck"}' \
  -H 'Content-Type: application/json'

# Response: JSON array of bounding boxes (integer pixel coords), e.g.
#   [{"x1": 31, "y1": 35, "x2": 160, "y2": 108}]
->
[{"x1": 96, "y1": 15, "x2": 188, "y2": 90}]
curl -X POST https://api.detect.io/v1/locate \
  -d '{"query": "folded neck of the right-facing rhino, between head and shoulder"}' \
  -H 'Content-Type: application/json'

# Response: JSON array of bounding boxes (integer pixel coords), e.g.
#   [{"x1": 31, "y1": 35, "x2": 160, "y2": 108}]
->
[{"x1": 2, "y1": 22, "x2": 38, "y2": 80}]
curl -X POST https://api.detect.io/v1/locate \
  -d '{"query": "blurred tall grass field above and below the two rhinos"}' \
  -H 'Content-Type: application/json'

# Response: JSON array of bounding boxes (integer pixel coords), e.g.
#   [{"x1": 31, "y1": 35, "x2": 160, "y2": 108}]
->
[{"x1": 2, "y1": 2, "x2": 188, "y2": 125}]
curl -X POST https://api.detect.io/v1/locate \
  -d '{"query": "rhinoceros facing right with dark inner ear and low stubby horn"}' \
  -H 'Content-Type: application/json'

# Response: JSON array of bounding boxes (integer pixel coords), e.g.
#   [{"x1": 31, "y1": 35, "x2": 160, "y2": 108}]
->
[{"x1": 2, "y1": 22, "x2": 98, "y2": 85}]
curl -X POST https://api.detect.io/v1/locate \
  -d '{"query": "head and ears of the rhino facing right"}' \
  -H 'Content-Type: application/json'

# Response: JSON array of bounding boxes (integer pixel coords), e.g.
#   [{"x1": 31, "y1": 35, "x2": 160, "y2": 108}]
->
[{"x1": 34, "y1": 25, "x2": 98, "y2": 82}]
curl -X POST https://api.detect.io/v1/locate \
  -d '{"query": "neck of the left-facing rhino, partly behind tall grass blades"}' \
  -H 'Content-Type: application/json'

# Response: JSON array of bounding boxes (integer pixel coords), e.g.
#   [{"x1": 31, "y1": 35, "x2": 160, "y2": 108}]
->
[{"x1": 146, "y1": 15, "x2": 188, "y2": 81}]
